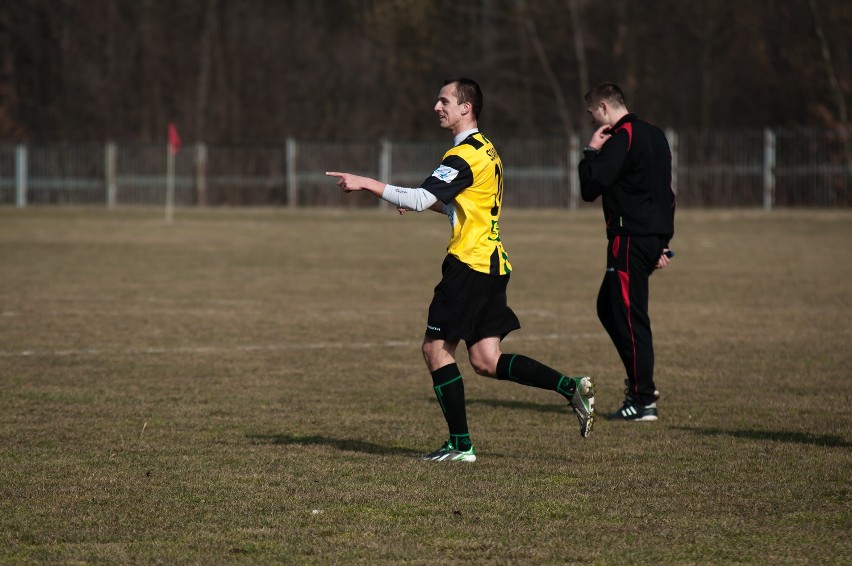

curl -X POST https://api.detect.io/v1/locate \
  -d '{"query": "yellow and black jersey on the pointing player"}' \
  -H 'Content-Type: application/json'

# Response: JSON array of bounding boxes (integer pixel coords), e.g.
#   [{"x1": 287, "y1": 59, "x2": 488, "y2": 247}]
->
[{"x1": 421, "y1": 132, "x2": 512, "y2": 275}]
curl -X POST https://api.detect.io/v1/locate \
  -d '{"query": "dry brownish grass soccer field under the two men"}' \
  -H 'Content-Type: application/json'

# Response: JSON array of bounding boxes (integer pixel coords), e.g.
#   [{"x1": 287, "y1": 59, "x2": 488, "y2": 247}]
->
[{"x1": 0, "y1": 208, "x2": 852, "y2": 564}]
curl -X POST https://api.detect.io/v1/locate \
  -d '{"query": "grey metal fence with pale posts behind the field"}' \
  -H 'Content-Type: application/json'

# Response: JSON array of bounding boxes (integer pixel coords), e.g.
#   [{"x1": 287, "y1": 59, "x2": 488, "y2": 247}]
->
[{"x1": 0, "y1": 129, "x2": 852, "y2": 210}]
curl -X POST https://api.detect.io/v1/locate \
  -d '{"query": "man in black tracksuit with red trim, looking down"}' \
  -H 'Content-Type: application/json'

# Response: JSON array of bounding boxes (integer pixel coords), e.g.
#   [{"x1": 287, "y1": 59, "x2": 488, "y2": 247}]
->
[{"x1": 579, "y1": 83, "x2": 675, "y2": 421}]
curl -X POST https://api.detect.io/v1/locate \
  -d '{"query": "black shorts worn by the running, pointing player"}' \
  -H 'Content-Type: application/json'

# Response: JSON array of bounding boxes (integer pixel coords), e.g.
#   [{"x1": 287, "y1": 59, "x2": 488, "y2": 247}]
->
[{"x1": 426, "y1": 255, "x2": 521, "y2": 346}]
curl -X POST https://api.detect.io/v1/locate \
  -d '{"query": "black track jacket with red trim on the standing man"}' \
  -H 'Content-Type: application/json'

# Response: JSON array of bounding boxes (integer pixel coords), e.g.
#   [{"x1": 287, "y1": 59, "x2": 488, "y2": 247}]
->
[{"x1": 579, "y1": 114, "x2": 675, "y2": 246}]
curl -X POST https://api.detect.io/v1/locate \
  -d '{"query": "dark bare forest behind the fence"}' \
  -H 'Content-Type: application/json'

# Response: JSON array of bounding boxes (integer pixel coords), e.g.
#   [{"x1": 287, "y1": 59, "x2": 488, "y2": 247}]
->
[{"x1": 0, "y1": 0, "x2": 852, "y2": 144}]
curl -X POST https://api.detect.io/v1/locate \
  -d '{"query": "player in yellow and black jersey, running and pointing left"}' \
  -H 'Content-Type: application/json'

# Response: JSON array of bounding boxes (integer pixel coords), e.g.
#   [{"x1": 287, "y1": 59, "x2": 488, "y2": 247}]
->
[{"x1": 327, "y1": 78, "x2": 594, "y2": 462}]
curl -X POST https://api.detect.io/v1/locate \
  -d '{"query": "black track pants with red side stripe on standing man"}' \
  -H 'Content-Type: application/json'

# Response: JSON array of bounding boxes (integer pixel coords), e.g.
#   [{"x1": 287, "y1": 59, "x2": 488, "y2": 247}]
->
[{"x1": 598, "y1": 236, "x2": 663, "y2": 405}]
